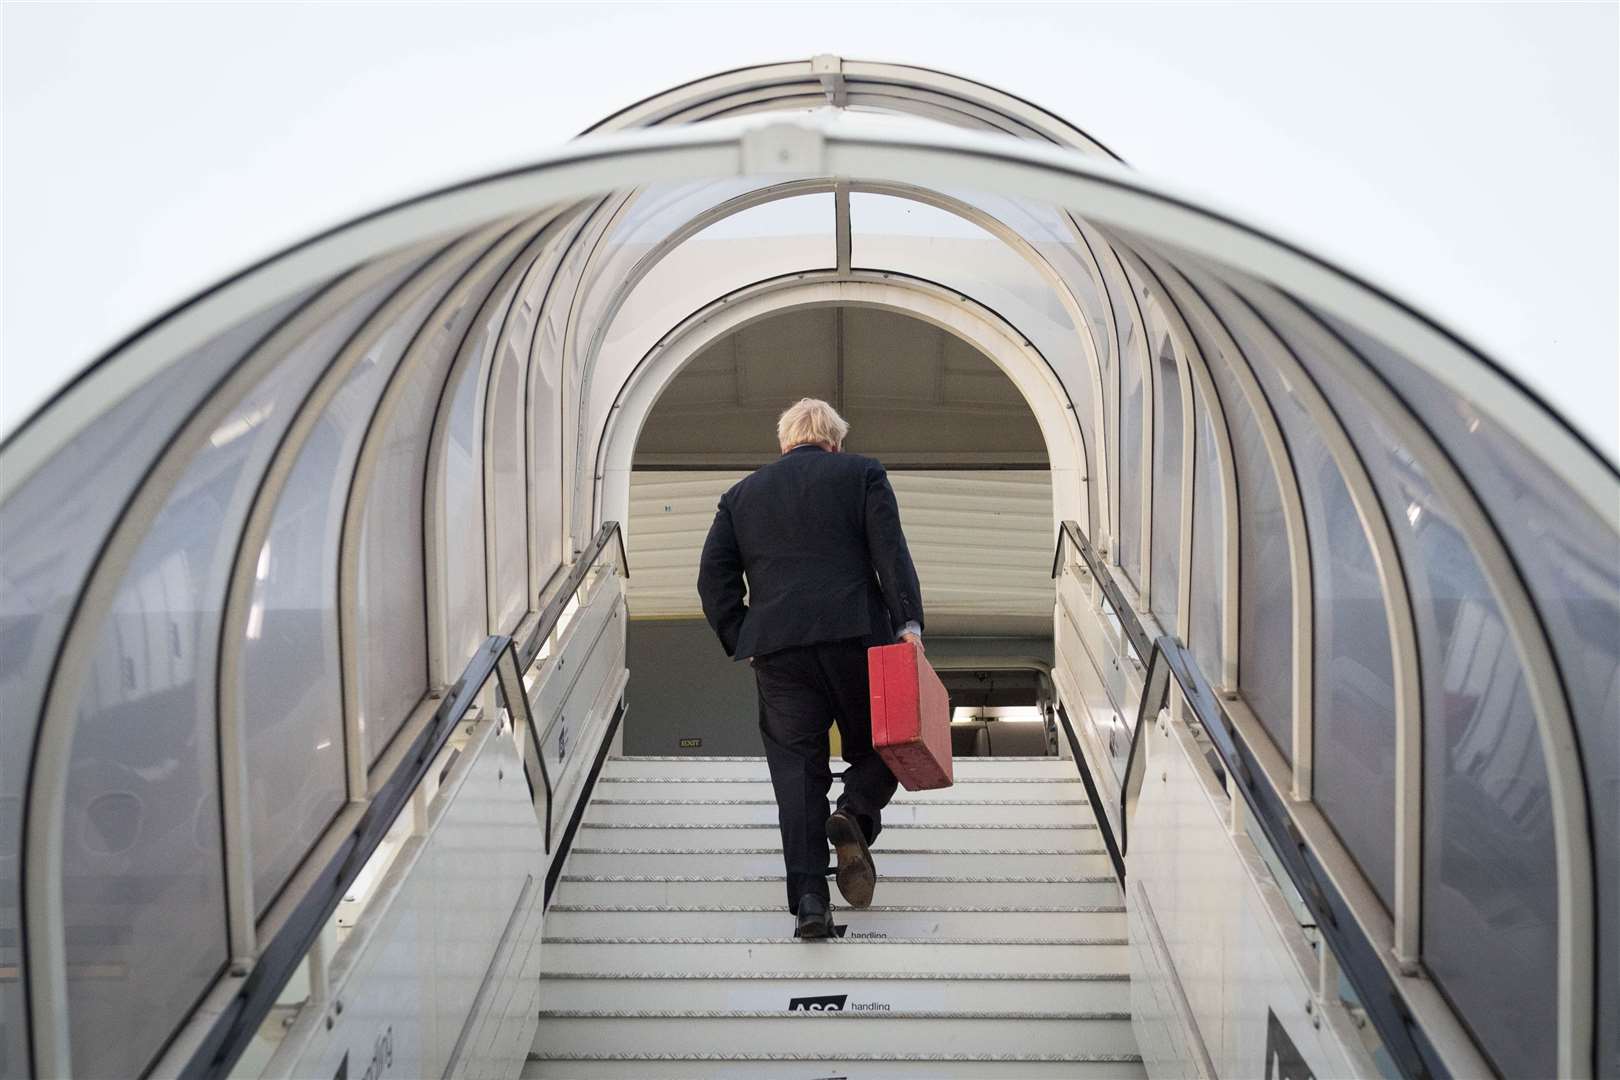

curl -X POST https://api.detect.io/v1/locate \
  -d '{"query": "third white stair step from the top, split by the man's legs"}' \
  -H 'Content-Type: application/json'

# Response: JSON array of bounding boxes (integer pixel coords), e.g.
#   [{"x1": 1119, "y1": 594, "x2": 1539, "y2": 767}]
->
[{"x1": 585, "y1": 797, "x2": 1097, "y2": 836}]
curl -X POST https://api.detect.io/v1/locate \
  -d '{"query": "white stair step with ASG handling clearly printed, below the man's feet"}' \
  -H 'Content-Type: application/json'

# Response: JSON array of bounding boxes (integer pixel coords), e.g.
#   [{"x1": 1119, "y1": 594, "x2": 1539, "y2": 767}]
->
[{"x1": 541, "y1": 968, "x2": 1131, "y2": 1012}]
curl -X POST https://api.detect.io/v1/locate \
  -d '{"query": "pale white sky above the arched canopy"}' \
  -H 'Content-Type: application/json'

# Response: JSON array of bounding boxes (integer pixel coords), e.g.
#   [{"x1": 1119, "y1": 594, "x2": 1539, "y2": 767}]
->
[{"x1": 0, "y1": 3, "x2": 1620, "y2": 460}]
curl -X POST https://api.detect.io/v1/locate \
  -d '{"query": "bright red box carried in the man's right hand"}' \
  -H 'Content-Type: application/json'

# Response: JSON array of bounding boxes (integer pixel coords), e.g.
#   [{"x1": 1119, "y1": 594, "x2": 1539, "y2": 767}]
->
[{"x1": 867, "y1": 641, "x2": 951, "y2": 792}]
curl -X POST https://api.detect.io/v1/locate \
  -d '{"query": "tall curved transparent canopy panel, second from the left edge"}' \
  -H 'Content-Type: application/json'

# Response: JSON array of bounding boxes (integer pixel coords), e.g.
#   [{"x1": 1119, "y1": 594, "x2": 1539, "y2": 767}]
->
[{"x1": 62, "y1": 254, "x2": 415, "y2": 1077}]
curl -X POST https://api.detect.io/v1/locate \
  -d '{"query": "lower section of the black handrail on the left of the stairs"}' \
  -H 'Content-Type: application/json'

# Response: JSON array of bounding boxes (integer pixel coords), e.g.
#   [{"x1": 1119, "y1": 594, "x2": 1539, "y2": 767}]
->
[{"x1": 181, "y1": 635, "x2": 512, "y2": 1078}]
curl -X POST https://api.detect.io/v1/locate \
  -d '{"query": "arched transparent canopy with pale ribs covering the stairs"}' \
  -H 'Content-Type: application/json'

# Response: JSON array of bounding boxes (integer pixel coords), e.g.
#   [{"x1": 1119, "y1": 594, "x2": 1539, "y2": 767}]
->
[{"x1": 0, "y1": 57, "x2": 1620, "y2": 1075}]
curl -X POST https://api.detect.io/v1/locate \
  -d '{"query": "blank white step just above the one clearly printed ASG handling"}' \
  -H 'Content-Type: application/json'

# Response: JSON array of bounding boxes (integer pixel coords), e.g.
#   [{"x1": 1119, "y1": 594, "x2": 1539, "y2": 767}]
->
[{"x1": 544, "y1": 934, "x2": 1129, "y2": 976}]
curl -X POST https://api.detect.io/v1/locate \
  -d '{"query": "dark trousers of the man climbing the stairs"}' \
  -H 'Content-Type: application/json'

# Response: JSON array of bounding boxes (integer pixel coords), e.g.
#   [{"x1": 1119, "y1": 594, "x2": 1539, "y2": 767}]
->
[{"x1": 753, "y1": 638, "x2": 896, "y2": 913}]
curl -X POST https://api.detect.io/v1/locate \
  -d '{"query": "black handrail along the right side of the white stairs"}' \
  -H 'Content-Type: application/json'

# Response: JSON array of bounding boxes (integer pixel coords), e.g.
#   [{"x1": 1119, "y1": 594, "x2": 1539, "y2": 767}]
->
[{"x1": 1053, "y1": 521, "x2": 1450, "y2": 1077}]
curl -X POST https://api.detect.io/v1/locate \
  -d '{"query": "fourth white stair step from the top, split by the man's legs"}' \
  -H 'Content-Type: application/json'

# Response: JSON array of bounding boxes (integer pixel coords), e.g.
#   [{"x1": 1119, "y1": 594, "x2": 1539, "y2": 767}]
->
[{"x1": 573, "y1": 821, "x2": 1100, "y2": 852}]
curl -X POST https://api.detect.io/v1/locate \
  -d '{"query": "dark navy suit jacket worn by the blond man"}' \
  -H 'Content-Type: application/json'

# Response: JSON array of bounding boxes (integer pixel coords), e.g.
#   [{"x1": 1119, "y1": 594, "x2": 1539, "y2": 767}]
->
[{"x1": 698, "y1": 447, "x2": 922, "y2": 659}]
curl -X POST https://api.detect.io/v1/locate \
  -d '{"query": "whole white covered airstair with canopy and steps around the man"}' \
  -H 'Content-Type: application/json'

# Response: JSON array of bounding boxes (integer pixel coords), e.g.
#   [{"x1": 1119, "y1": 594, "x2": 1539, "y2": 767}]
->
[{"x1": 0, "y1": 55, "x2": 1620, "y2": 1080}]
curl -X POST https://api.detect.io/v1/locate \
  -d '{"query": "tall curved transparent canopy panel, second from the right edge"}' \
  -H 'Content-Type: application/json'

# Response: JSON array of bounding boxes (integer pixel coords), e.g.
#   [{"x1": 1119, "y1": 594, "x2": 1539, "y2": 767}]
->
[{"x1": 1267, "y1": 298, "x2": 1558, "y2": 1077}]
